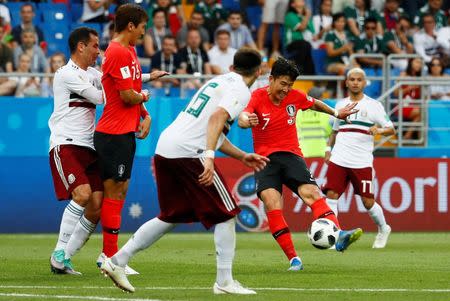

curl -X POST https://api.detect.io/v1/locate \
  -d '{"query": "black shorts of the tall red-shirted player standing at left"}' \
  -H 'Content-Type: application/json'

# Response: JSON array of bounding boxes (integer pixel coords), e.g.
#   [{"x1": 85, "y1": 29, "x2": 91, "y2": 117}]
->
[{"x1": 94, "y1": 132, "x2": 136, "y2": 182}]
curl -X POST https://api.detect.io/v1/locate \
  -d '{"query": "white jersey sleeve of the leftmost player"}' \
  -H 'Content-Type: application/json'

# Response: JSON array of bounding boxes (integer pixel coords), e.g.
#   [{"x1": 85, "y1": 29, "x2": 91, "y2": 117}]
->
[{"x1": 62, "y1": 72, "x2": 103, "y2": 104}]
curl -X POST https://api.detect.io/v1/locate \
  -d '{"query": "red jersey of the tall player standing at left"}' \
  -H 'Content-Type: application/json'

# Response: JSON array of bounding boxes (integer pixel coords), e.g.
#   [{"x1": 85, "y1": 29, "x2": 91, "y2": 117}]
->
[{"x1": 96, "y1": 41, "x2": 142, "y2": 134}]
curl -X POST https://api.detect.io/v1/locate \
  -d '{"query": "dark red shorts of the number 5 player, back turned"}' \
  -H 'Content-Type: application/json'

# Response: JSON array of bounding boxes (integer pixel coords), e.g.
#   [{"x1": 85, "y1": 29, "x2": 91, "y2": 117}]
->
[{"x1": 155, "y1": 155, "x2": 241, "y2": 229}]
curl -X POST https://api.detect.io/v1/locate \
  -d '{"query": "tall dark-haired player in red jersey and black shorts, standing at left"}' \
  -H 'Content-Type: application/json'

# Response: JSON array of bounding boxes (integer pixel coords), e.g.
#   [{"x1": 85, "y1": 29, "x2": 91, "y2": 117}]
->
[{"x1": 94, "y1": 4, "x2": 168, "y2": 272}]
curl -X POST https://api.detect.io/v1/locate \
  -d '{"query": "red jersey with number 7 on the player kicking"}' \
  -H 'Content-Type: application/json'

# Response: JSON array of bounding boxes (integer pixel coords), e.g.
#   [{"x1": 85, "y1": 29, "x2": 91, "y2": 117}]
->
[{"x1": 244, "y1": 87, "x2": 315, "y2": 157}]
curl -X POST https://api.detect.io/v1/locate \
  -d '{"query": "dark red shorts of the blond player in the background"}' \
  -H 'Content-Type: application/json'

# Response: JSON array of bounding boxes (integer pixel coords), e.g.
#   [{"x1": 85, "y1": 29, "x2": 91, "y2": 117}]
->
[{"x1": 322, "y1": 162, "x2": 373, "y2": 198}]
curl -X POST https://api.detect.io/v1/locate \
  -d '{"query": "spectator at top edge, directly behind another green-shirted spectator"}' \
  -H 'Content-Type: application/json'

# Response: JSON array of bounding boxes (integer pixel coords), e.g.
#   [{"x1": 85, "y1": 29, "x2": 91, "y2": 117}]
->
[{"x1": 344, "y1": 0, "x2": 383, "y2": 37}]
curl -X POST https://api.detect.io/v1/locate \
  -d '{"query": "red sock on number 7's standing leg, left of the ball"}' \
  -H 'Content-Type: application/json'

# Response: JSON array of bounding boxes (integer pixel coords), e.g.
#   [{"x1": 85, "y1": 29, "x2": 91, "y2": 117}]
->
[{"x1": 267, "y1": 209, "x2": 297, "y2": 260}]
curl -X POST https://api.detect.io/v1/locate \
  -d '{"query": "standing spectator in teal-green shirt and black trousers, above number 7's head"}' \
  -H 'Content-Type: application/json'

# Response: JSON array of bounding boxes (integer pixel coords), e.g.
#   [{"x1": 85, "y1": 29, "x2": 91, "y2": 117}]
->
[{"x1": 284, "y1": 0, "x2": 315, "y2": 75}]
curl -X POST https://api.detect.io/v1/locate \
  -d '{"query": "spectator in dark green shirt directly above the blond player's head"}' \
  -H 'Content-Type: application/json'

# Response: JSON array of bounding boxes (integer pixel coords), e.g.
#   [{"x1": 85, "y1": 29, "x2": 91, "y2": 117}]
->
[{"x1": 355, "y1": 18, "x2": 384, "y2": 69}]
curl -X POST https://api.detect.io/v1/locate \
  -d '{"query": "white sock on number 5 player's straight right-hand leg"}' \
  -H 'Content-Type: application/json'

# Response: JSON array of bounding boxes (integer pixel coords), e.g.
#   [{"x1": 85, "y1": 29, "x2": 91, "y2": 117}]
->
[{"x1": 214, "y1": 218, "x2": 236, "y2": 286}]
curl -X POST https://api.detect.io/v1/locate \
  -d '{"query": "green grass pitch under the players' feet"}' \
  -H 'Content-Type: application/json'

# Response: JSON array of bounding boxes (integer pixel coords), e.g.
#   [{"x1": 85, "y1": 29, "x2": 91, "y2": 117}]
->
[{"x1": 0, "y1": 233, "x2": 450, "y2": 301}]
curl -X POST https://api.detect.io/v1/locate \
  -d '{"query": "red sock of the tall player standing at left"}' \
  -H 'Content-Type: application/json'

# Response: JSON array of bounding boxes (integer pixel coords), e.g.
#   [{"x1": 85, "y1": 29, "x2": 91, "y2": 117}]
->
[{"x1": 100, "y1": 198, "x2": 124, "y2": 257}]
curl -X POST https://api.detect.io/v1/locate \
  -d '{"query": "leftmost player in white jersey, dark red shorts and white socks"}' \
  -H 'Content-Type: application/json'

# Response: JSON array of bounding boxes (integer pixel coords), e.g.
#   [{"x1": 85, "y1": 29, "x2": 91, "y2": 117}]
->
[{"x1": 49, "y1": 27, "x2": 103, "y2": 274}]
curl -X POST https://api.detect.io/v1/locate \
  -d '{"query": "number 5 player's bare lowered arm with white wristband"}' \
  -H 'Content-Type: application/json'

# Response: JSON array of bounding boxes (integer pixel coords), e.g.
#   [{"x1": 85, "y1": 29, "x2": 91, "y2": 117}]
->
[{"x1": 199, "y1": 107, "x2": 230, "y2": 186}]
